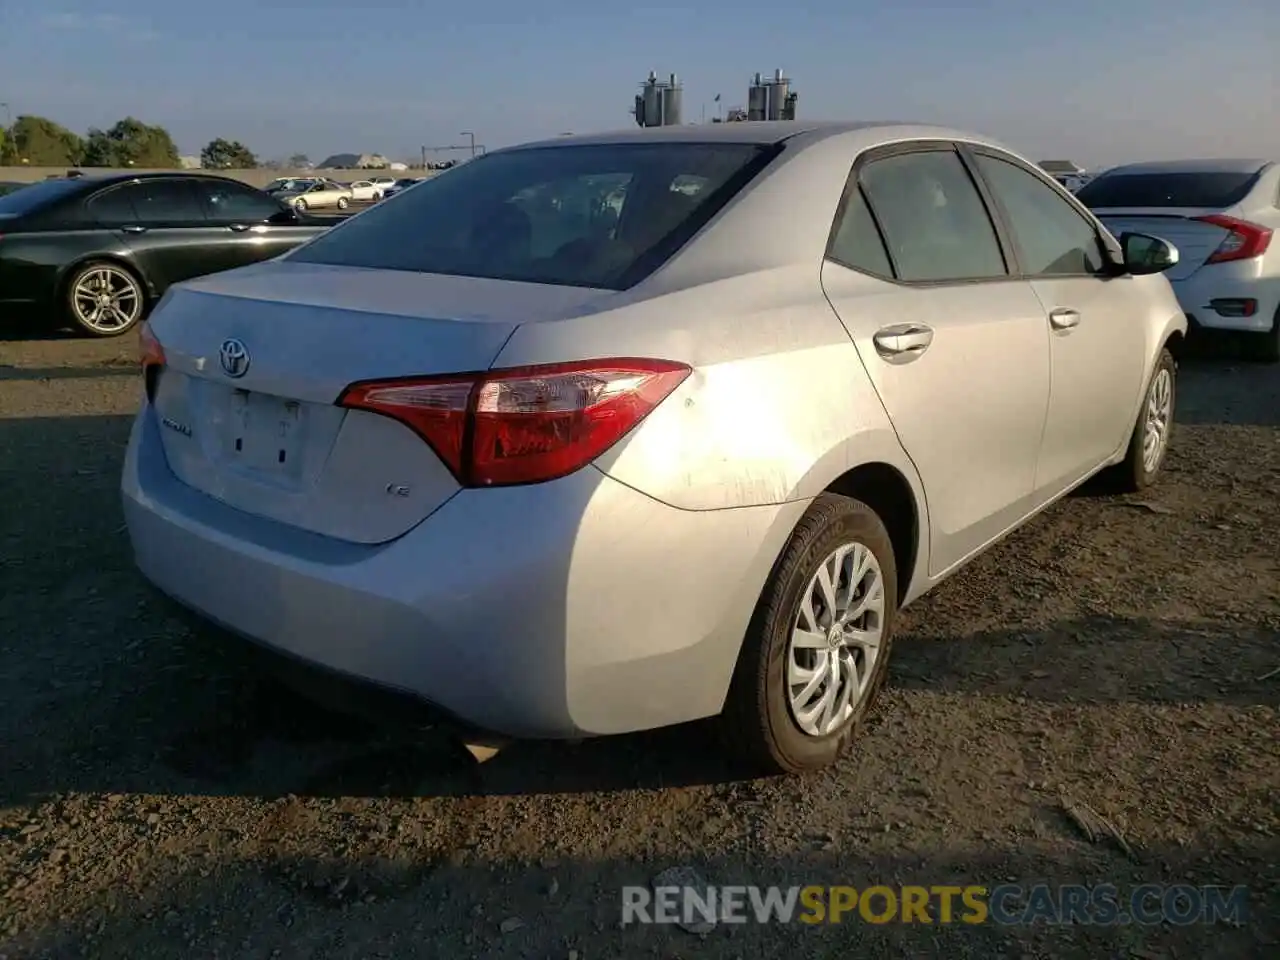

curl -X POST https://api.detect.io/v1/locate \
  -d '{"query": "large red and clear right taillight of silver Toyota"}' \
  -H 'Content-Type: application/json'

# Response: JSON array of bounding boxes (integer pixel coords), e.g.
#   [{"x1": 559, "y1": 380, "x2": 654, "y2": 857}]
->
[{"x1": 338, "y1": 358, "x2": 691, "y2": 486}]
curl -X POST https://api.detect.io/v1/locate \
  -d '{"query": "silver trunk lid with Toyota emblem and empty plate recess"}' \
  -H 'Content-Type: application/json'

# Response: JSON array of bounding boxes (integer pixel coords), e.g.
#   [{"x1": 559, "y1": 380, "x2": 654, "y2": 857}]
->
[{"x1": 151, "y1": 261, "x2": 614, "y2": 543}]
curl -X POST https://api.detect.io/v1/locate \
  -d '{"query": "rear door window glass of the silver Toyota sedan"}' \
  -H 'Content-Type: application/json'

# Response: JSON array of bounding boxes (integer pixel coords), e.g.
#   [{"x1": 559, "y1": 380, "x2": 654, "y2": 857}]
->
[{"x1": 860, "y1": 150, "x2": 1007, "y2": 282}]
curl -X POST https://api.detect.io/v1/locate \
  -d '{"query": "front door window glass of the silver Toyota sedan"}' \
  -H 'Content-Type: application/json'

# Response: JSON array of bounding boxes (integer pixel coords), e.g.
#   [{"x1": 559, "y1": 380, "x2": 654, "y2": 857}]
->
[{"x1": 978, "y1": 154, "x2": 1105, "y2": 276}]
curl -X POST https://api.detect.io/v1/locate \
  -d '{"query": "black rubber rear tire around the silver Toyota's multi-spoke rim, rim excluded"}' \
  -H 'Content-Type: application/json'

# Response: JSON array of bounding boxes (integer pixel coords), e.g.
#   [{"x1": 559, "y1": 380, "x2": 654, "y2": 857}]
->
[{"x1": 719, "y1": 494, "x2": 897, "y2": 773}]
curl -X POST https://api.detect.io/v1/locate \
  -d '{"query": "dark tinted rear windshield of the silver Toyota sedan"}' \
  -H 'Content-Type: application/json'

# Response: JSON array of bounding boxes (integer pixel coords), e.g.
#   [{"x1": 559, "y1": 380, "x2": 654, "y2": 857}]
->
[{"x1": 288, "y1": 142, "x2": 772, "y2": 289}]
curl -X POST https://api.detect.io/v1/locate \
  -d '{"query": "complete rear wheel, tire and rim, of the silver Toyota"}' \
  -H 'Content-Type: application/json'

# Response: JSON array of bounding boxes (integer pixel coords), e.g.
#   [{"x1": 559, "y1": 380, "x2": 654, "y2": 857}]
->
[{"x1": 721, "y1": 494, "x2": 897, "y2": 773}]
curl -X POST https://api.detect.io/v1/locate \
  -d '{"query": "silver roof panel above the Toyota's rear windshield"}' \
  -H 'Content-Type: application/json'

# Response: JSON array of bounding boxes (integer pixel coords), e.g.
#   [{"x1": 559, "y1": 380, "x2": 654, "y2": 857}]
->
[{"x1": 504, "y1": 120, "x2": 983, "y2": 152}]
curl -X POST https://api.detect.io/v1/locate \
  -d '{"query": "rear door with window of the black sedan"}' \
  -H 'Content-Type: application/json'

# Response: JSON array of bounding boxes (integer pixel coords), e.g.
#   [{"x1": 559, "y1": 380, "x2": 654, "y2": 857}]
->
[{"x1": 88, "y1": 177, "x2": 228, "y2": 289}]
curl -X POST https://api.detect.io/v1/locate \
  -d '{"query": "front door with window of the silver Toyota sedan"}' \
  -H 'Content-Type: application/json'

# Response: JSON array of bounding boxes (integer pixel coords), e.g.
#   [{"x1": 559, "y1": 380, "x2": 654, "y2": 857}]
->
[{"x1": 972, "y1": 147, "x2": 1147, "y2": 497}]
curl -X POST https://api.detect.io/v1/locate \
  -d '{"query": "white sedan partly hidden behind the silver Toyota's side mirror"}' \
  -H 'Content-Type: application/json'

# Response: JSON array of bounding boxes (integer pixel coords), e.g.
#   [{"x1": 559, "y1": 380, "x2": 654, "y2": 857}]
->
[{"x1": 1076, "y1": 160, "x2": 1280, "y2": 364}]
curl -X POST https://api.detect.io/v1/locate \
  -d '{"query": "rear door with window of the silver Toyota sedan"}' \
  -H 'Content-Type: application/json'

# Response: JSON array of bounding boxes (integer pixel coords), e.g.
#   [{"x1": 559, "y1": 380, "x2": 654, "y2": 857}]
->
[{"x1": 822, "y1": 142, "x2": 1050, "y2": 575}]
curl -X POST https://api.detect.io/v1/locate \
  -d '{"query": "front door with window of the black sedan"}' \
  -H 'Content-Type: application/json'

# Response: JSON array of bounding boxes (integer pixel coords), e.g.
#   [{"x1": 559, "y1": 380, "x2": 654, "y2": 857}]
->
[{"x1": 196, "y1": 179, "x2": 319, "y2": 270}]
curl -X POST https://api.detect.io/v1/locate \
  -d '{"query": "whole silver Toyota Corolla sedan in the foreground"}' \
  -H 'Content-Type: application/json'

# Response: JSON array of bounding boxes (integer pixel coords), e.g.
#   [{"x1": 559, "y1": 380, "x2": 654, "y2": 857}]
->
[{"x1": 123, "y1": 123, "x2": 1185, "y2": 771}]
